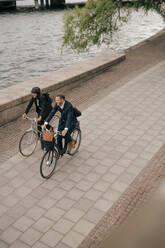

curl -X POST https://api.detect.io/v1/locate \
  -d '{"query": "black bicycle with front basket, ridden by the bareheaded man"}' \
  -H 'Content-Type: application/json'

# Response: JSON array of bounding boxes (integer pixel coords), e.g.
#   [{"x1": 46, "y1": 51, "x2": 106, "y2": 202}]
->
[{"x1": 40, "y1": 122, "x2": 81, "y2": 179}]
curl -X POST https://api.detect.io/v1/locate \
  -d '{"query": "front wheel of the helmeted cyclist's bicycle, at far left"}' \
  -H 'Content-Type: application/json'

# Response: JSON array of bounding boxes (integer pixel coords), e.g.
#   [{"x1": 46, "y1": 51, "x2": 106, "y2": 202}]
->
[{"x1": 19, "y1": 130, "x2": 38, "y2": 157}]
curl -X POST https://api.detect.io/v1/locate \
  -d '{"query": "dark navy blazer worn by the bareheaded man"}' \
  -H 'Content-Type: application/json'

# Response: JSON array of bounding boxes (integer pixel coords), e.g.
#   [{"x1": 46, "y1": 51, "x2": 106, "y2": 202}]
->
[{"x1": 46, "y1": 101, "x2": 77, "y2": 131}]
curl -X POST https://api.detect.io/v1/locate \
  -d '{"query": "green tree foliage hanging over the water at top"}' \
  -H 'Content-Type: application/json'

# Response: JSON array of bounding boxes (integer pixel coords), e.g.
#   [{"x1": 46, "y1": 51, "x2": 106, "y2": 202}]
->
[{"x1": 63, "y1": 0, "x2": 165, "y2": 52}]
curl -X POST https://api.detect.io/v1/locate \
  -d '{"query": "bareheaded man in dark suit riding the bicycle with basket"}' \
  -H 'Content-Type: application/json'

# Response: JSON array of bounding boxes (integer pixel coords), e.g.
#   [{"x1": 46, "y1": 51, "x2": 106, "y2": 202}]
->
[{"x1": 42, "y1": 95, "x2": 77, "y2": 156}]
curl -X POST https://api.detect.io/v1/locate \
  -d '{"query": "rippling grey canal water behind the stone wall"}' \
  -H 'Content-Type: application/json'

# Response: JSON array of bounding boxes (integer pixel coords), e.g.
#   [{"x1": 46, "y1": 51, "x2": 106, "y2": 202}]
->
[{"x1": 0, "y1": 0, "x2": 165, "y2": 89}]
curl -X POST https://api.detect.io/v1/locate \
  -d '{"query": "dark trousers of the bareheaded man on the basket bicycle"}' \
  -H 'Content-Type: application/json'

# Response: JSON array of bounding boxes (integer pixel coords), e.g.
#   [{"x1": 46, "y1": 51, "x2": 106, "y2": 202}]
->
[{"x1": 57, "y1": 127, "x2": 75, "y2": 154}]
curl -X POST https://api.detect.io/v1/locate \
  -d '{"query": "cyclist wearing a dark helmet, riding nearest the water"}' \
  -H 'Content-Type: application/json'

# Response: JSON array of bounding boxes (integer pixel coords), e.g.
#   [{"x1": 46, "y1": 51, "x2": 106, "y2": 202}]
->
[{"x1": 22, "y1": 87, "x2": 52, "y2": 135}]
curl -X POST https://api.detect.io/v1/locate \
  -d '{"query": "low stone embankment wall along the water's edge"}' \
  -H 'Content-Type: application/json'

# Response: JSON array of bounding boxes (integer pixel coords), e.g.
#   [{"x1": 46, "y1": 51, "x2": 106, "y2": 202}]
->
[{"x1": 0, "y1": 53, "x2": 126, "y2": 126}]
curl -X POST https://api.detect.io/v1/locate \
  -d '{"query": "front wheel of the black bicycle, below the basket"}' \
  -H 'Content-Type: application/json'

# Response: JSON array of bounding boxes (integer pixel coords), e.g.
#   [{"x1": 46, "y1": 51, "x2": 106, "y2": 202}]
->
[{"x1": 40, "y1": 150, "x2": 58, "y2": 179}]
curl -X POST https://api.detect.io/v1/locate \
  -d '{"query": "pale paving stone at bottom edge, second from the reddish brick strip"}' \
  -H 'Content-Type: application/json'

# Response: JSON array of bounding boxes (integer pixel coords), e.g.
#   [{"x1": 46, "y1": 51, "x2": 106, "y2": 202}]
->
[{"x1": 41, "y1": 230, "x2": 63, "y2": 248}]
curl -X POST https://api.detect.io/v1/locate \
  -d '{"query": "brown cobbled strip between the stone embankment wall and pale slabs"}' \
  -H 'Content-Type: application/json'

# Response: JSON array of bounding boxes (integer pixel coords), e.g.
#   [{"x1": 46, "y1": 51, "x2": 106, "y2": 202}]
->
[{"x1": 0, "y1": 28, "x2": 165, "y2": 163}]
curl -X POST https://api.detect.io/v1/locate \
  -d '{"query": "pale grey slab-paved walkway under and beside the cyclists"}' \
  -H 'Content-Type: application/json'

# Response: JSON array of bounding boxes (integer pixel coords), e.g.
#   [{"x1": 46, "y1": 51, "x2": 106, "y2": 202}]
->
[{"x1": 0, "y1": 61, "x2": 165, "y2": 248}]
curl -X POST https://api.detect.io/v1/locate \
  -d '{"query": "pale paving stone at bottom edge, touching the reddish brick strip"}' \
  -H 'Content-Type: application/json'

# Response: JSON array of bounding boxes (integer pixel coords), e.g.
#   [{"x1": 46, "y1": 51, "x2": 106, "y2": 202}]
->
[{"x1": 62, "y1": 231, "x2": 84, "y2": 248}]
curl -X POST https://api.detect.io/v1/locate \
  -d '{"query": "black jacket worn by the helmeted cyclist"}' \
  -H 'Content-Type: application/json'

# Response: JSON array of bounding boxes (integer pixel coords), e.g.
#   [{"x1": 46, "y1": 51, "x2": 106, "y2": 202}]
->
[{"x1": 25, "y1": 94, "x2": 52, "y2": 119}]
